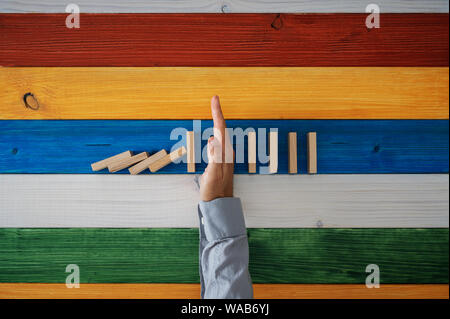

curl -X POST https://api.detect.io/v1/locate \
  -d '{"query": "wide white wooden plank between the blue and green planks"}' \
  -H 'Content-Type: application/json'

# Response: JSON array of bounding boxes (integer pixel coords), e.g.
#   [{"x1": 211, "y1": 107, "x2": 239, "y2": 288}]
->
[{"x1": 0, "y1": 174, "x2": 449, "y2": 228}]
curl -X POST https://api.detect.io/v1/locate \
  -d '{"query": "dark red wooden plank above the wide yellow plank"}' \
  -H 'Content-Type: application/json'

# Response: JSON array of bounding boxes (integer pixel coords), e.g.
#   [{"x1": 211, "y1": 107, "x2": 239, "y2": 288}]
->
[{"x1": 0, "y1": 13, "x2": 449, "y2": 67}]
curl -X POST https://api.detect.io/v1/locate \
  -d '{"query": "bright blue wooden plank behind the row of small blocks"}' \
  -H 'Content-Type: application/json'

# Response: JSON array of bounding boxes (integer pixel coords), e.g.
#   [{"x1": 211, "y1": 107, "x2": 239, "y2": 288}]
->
[{"x1": 0, "y1": 120, "x2": 449, "y2": 174}]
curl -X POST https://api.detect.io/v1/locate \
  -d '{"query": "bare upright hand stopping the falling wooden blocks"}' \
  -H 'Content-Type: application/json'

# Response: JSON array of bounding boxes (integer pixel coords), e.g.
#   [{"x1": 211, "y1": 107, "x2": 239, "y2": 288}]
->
[{"x1": 200, "y1": 95, "x2": 234, "y2": 202}]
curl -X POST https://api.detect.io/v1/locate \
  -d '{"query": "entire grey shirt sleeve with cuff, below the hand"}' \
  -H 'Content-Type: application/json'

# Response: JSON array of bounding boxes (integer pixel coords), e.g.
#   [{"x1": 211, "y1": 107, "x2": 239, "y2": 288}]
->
[{"x1": 198, "y1": 197, "x2": 253, "y2": 299}]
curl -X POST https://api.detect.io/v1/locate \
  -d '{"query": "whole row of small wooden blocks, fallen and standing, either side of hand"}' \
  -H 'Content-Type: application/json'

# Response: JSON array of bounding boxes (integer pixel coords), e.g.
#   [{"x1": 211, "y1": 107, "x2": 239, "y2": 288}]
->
[{"x1": 91, "y1": 131, "x2": 317, "y2": 175}]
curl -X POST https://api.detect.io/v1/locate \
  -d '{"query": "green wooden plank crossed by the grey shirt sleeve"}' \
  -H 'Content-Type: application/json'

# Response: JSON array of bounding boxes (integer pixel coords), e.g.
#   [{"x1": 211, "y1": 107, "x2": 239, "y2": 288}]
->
[{"x1": 0, "y1": 228, "x2": 449, "y2": 284}]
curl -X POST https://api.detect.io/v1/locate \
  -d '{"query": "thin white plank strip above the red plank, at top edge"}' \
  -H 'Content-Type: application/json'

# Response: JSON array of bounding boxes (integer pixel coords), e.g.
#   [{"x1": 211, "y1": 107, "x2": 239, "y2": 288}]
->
[{"x1": 0, "y1": 0, "x2": 449, "y2": 13}]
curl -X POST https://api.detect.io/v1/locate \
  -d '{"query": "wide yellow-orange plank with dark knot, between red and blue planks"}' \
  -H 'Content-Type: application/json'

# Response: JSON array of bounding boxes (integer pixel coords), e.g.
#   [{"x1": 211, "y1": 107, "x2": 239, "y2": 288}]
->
[{"x1": 0, "y1": 67, "x2": 449, "y2": 120}]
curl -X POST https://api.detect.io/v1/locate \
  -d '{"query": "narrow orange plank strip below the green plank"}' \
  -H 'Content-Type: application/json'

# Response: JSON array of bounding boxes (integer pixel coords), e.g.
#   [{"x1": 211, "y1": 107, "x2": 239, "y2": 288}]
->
[{"x1": 0, "y1": 283, "x2": 449, "y2": 299}]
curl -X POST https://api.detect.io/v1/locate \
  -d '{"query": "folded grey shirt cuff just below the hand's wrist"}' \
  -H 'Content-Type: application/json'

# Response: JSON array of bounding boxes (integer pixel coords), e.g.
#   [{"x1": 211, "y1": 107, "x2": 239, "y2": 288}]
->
[{"x1": 198, "y1": 197, "x2": 247, "y2": 241}]
